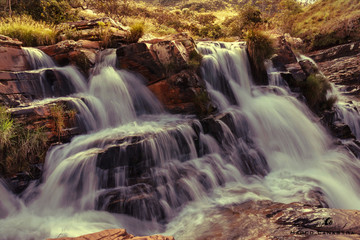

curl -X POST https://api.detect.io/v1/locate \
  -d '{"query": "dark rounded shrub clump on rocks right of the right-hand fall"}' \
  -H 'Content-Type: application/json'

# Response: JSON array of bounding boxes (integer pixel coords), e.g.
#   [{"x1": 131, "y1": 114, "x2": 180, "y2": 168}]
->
[{"x1": 300, "y1": 74, "x2": 336, "y2": 111}]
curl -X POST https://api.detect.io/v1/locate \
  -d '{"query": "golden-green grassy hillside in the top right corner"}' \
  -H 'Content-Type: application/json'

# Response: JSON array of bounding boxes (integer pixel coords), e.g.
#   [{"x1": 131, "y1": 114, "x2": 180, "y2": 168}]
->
[{"x1": 292, "y1": 0, "x2": 360, "y2": 49}]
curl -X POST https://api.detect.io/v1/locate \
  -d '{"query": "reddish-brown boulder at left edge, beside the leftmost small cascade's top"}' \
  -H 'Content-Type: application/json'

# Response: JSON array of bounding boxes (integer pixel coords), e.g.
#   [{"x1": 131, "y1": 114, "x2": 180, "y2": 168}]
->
[{"x1": 0, "y1": 35, "x2": 30, "y2": 71}]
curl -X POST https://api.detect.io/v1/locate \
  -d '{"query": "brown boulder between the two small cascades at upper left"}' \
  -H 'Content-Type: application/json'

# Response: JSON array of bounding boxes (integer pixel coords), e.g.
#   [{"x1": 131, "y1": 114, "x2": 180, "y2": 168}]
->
[{"x1": 40, "y1": 40, "x2": 101, "y2": 75}]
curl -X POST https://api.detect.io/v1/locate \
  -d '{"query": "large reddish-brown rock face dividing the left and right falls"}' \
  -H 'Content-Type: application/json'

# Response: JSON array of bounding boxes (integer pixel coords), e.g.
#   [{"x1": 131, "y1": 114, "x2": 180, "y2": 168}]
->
[{"x1": 116, "y1": 34, "x2": 210, "y2": 114}]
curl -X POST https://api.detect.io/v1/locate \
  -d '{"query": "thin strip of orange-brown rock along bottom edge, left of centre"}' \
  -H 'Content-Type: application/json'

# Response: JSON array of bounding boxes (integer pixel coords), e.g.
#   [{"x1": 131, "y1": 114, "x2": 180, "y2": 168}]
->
[{"x1": 48, "y1": 229, "x2": 175, "y2": 240}]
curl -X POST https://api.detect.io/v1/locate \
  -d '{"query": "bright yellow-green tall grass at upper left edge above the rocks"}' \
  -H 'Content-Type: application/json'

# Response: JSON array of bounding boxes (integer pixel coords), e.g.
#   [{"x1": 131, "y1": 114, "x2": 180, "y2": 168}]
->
[{"x1": 0, "y1": 15, "x2": 56, "y2": 46}]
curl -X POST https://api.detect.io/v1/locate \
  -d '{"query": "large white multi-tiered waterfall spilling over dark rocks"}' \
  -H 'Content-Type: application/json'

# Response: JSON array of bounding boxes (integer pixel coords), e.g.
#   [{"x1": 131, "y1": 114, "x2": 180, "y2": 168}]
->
[{"x1": 0, "y1": 43, "x2": 360, "y2": 239}]
